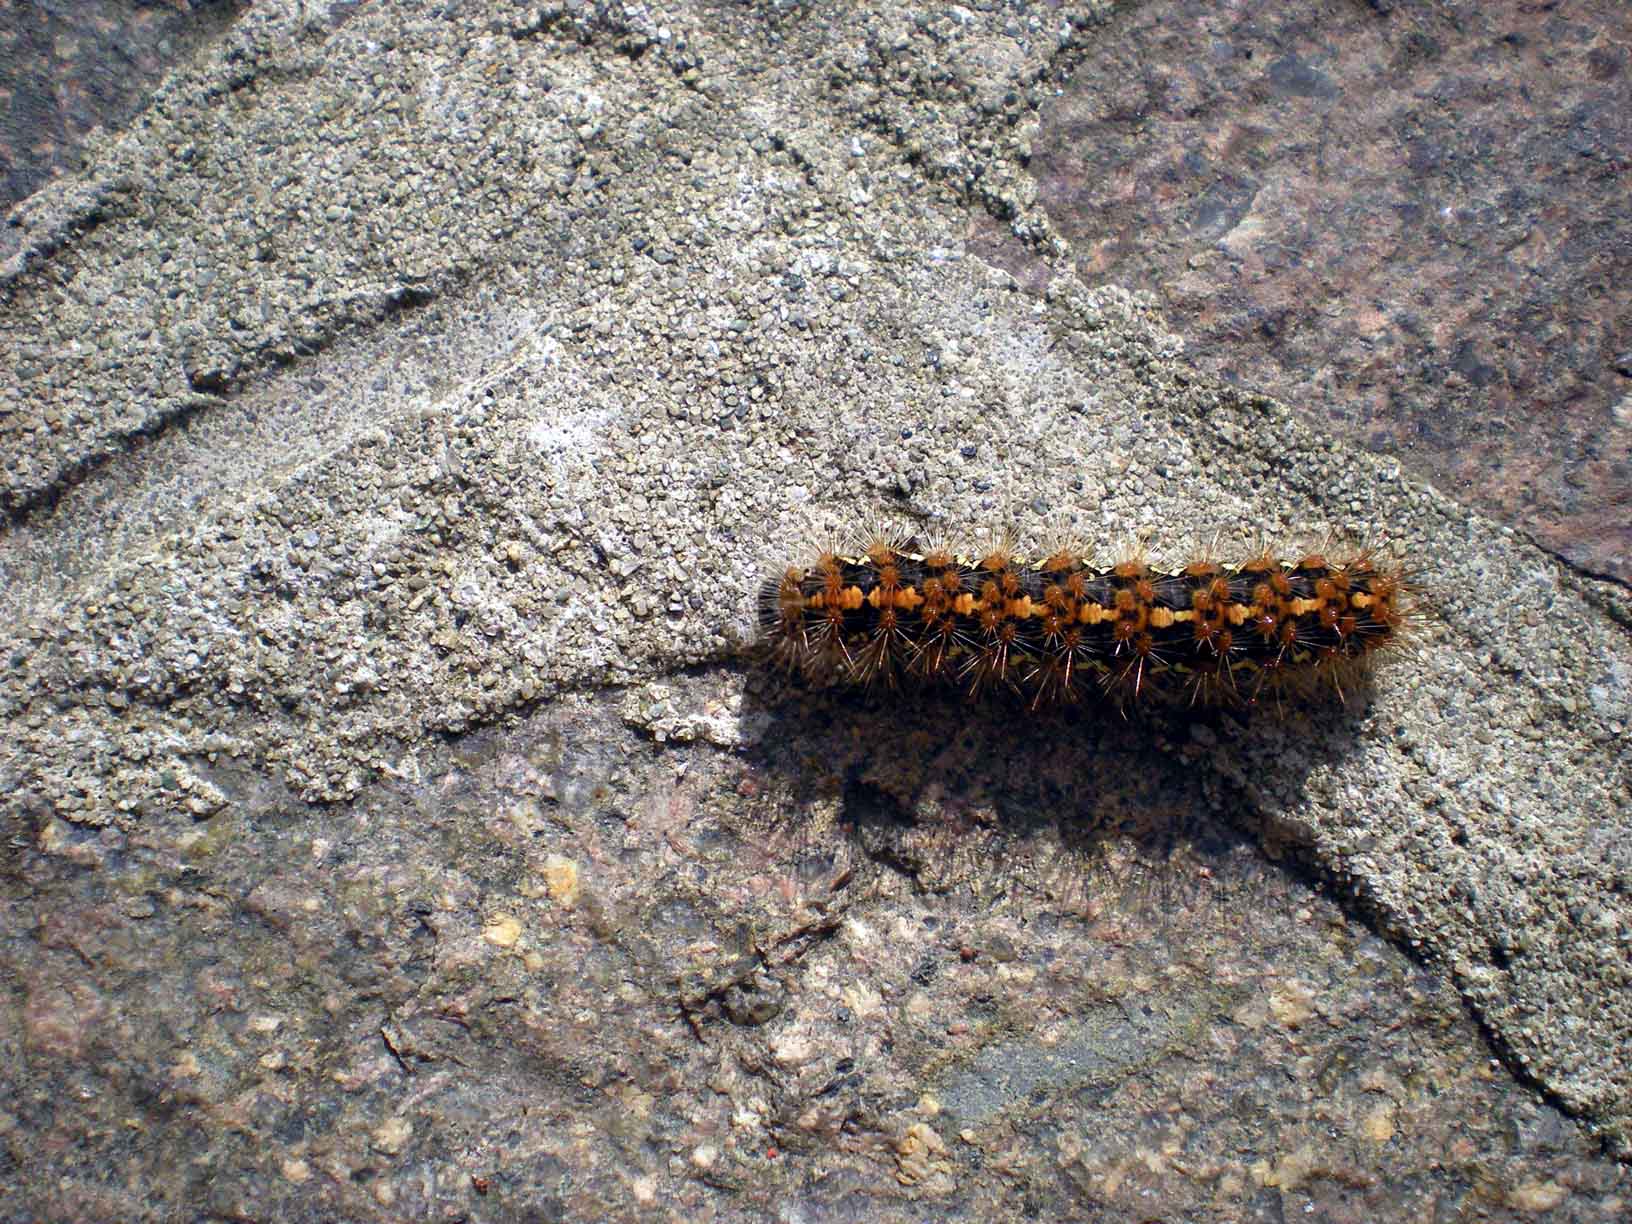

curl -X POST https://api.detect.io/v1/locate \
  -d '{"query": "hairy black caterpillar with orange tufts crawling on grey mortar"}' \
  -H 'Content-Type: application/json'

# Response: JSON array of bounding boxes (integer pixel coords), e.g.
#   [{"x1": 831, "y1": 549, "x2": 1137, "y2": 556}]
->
[{"x1": 759, "y1": 537, "x2": 1407, "y2": 708}]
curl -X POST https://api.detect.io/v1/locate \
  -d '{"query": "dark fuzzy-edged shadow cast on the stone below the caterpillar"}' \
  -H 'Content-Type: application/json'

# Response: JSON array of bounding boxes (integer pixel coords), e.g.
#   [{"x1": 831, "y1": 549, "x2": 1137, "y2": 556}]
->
[{"x1": 744, "y1": 671, "x2": 1368, "y2": 916}]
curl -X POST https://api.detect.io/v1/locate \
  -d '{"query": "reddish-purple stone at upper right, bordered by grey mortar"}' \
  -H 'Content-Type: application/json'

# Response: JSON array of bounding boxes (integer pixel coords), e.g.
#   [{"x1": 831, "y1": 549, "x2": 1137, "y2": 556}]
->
[{"x1": 1031, "y1": 0, "x2": 1632, "y2": 583}]
